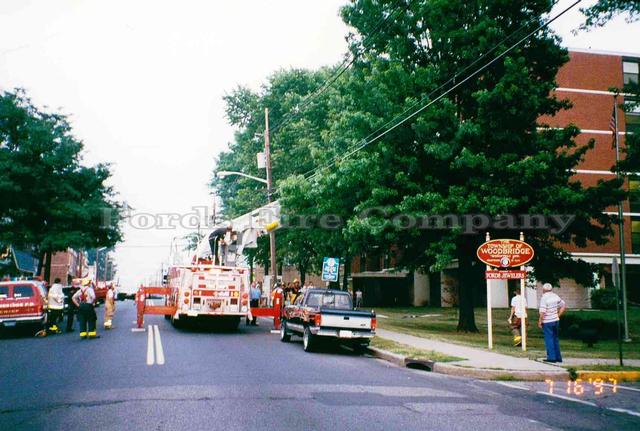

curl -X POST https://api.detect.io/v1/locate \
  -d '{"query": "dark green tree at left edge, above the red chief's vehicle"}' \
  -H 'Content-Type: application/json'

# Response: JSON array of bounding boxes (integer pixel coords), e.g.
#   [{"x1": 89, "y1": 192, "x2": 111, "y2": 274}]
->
[{"x1": 0, "y1": 90, "x2": 122, "y2": 275}]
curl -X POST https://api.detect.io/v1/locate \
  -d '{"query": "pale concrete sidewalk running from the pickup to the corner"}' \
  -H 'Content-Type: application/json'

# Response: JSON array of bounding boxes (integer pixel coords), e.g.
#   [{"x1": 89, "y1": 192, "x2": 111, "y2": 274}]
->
[{"x1": 376, "y1": 329, "x2": 567, "y2": 380}]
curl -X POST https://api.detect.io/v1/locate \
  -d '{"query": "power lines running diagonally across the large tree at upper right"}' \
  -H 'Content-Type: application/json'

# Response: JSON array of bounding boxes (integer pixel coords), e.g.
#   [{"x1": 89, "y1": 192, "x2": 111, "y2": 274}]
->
[{"x1": 303, "y1": 0, "x2": 582, "y2": 179}]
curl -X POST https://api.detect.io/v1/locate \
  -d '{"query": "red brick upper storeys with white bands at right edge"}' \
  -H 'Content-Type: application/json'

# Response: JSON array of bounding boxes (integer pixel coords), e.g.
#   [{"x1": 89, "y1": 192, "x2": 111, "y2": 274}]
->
[{"x1": 548, "y1": 50, "x2": 640, "y2": 306}]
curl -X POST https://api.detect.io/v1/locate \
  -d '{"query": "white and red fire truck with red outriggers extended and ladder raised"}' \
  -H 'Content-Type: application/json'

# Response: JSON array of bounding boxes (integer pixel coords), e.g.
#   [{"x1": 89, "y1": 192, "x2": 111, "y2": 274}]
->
[{"x1": 136, "y1": 202, "x2": 281, "y2": 329}]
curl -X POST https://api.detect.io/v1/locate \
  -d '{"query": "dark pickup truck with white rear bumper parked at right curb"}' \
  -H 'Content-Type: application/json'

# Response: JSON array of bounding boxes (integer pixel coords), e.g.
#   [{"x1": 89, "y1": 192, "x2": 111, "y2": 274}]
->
[{"x1": 280, "y1": 289, "x2": 377, "y2": 352}]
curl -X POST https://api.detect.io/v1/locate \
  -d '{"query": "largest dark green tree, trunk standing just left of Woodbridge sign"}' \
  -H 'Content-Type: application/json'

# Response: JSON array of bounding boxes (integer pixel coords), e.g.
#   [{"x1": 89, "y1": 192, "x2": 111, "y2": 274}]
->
[{"x1": 342, "y1": 0, "x2": 621, "y2": 331}]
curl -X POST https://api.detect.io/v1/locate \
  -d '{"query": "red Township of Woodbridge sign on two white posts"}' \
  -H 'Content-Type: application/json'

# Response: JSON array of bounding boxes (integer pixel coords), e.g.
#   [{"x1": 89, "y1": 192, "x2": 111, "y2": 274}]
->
[{"x1": 477, "y1": 236, "x2": 534, "y2": 351}]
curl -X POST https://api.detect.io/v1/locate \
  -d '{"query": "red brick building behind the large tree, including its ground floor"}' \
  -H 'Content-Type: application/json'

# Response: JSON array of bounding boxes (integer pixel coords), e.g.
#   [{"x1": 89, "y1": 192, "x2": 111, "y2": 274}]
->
[{"x1": 352, "y1": 50, "x2": 640, "y2": 308}]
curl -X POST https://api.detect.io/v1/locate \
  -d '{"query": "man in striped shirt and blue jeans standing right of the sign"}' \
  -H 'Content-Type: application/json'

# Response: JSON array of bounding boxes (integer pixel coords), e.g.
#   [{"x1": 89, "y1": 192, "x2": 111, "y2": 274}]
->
[{"x1": 538, "y1": 283, "x2": 567, "y2": 362}]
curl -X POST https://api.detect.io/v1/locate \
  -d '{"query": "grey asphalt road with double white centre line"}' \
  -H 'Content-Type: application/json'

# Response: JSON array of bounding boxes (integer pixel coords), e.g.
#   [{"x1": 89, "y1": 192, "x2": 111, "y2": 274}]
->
[{"x1": 0, "y1": 301, "x2": 640, "y2": 431}]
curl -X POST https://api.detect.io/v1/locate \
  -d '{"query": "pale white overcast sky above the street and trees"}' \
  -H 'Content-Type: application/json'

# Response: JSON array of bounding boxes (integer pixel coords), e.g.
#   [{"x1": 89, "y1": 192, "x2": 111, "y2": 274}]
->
[{"x1": 0, "y1": 0, "x2": 640, "y2": 290}]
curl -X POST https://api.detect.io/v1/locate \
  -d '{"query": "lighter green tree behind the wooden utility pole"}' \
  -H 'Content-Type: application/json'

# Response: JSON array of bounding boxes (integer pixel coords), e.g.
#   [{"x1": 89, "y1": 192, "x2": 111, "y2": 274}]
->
[{"x1": 211, "y1": 68, "x2": 350, "y2": 275}]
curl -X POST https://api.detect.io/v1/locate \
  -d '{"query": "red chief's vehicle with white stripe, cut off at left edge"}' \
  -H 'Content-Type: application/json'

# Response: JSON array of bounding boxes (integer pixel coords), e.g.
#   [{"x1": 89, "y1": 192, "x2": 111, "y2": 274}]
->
[{"x1": 0, "y1": 280, "x2": 47, "y2": 329}]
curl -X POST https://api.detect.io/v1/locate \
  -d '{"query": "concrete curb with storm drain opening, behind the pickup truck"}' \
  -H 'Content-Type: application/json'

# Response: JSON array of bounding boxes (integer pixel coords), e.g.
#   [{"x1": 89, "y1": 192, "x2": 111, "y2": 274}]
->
[{"x1": 368, "y1": 347, "x2": 569, "y2": 381}]
